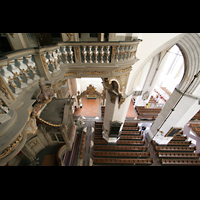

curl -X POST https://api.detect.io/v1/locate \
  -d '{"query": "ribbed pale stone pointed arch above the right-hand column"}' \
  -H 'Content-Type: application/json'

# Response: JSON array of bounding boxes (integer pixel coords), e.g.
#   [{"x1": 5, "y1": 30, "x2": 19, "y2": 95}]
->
[{"x1": 131, "y1": 33, "x2": 200, "y2": 94}]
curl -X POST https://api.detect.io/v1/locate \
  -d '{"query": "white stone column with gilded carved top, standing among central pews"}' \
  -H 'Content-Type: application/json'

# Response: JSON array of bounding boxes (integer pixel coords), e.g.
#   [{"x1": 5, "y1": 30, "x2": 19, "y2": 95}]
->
[{"x1": 102, "y1": 74, "x2": 131, "y2": 143}]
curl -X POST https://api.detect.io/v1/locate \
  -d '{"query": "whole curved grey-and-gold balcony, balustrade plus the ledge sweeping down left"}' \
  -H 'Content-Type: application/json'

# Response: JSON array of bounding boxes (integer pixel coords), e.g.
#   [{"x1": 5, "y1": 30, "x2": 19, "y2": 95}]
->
[{"x1": 0, "y1": 40, "x2": 140, "y2": 164}]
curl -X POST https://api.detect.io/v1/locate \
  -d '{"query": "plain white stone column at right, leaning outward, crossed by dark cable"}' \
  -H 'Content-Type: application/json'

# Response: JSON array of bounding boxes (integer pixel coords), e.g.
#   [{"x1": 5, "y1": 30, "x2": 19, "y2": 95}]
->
[{"x1": 147, "y1": 88, "x2": 200, "y2": 144}]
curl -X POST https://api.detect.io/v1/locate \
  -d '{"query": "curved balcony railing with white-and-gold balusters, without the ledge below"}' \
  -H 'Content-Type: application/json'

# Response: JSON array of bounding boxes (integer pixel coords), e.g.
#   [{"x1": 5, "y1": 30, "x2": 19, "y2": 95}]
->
[{"x1": 0, "y1": 40, "x2": 140, "y2": 97}]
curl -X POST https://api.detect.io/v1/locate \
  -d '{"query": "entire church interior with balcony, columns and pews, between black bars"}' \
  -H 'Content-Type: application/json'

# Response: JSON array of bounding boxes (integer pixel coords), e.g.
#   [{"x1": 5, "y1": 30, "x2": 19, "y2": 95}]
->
[{"x1": 0, "y1": 33, "x2": 200, "y2": 166}]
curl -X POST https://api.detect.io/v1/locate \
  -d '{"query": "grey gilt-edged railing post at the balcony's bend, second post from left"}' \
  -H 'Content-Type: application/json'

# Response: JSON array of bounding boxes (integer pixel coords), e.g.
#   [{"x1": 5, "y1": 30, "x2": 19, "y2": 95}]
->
[{"x1": 34, "y1": 49, "x2": 51, "y2": 80}]
